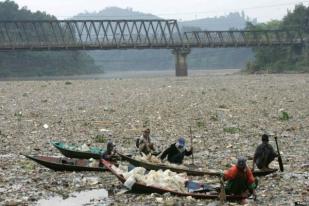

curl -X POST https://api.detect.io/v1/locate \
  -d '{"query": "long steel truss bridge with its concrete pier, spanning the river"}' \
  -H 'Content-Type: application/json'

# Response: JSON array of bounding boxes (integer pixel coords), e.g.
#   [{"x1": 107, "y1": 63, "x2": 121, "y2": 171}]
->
[{"x1": 0, "y1": 19, "x2": 304, "y2": 76}]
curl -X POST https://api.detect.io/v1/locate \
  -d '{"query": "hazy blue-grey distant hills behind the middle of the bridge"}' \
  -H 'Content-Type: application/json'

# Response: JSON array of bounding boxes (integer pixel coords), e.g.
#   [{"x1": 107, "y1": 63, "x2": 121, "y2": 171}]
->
[{"x1": 72, "y1": 7, "x2": 253, "y2": 71}]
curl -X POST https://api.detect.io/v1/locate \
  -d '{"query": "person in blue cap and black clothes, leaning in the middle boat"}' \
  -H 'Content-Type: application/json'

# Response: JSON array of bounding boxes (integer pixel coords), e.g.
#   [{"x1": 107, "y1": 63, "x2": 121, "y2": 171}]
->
[{"x1": 160, "y1": 137, "x2": 193, "y2": 164}]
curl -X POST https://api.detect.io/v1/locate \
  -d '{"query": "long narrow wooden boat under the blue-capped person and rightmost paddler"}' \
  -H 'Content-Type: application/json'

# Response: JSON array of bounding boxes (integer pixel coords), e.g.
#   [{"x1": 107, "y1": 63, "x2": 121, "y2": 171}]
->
[{"x1": 118, "y1": 153, "x2": 277, "y2": 177}]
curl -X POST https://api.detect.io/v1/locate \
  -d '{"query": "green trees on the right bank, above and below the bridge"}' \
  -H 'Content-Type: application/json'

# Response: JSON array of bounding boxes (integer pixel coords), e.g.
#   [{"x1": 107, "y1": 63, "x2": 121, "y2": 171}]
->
[{"x1": 244, "y1": 5, "x2": 309, "y2": 73}]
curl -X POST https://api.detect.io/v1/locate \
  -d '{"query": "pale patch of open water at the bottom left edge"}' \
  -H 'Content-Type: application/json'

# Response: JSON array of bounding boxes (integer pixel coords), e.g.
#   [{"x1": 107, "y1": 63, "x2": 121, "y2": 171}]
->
[{"x1": 37, "y1": 189, "x2": 109, "y2": 206}]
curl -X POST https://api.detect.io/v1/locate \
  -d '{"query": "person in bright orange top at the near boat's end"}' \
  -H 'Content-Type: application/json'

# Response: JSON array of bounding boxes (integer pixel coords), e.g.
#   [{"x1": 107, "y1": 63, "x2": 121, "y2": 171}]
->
[{"x1": 223, "y1": 157, "x2": 257, "y2": 203}]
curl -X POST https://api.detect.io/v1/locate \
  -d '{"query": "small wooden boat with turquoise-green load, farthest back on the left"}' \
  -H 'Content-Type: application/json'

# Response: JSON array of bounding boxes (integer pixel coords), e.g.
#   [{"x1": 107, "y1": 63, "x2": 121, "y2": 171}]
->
[{"x1": 51, "y1": 141, "x2": 104, "y2": 159}]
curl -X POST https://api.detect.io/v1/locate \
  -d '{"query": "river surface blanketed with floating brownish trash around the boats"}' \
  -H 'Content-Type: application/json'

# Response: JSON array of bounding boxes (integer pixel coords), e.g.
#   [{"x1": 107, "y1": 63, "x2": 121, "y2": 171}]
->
[{"x1": 0, "y1": 71, "x2": 309, "y2": 206}]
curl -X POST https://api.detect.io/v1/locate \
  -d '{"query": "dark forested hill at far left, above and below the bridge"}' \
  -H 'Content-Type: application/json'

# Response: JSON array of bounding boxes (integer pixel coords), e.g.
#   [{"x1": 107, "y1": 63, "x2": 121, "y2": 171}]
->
[{"x1": 0, "y1": 1, "x2": 102, "y2": 78}]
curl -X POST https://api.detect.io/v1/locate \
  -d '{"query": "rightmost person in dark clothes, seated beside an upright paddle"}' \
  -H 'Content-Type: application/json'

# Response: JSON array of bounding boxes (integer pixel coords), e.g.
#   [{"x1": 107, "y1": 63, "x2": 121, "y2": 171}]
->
[{"x1": 252, "y1": 134, "x2": 278, "y2": 171}]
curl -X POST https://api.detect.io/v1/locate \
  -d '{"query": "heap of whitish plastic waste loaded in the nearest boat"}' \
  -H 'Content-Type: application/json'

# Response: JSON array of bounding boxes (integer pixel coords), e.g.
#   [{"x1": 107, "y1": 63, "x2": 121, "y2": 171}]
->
[{"x1": 112, "y1": 166, "x2": 188, "y2": 192}]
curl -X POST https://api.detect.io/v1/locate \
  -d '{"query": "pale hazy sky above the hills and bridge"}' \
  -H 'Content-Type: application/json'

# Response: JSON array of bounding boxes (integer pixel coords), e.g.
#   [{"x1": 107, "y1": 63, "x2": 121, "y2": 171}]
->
[{"x1": 8, "y1": 0, "x2": 309, "y2": 22}]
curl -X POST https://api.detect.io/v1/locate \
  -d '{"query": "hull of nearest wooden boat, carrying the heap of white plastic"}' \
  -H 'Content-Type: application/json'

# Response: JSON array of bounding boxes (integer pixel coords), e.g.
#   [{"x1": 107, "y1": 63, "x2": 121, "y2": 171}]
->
[{"x1": 101, "y1": 160, "x2": 244, "y2": 200}]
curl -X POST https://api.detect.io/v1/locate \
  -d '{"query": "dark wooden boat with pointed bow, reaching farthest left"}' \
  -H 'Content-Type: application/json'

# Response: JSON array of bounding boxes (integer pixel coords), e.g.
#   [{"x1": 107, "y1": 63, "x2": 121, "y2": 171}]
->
[{"x1": 24, "y1": 155, "x2": 106, "y2": 172}]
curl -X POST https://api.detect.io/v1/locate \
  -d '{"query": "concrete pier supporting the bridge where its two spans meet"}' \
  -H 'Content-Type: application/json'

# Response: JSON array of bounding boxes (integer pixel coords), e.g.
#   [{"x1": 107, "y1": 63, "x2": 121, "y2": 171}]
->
[{"x1": 172, "y1": 48, "x2": 191, "y2": 77}]
